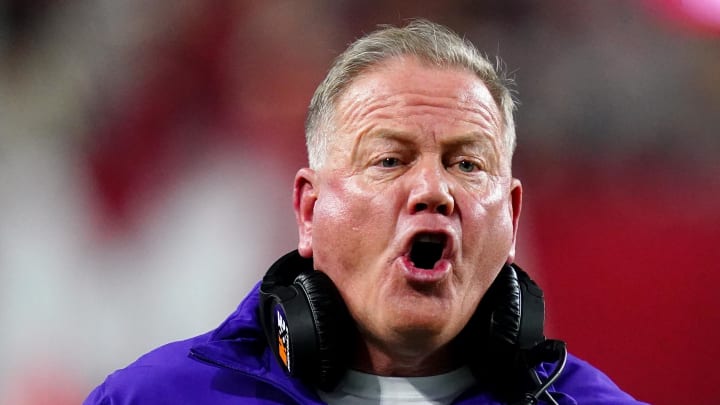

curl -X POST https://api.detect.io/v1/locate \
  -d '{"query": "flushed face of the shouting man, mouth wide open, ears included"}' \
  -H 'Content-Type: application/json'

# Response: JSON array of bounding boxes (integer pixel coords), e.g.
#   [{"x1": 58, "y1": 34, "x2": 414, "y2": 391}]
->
[{"x1": 295, "y1": 57, "x2": 521, "y2": 372}]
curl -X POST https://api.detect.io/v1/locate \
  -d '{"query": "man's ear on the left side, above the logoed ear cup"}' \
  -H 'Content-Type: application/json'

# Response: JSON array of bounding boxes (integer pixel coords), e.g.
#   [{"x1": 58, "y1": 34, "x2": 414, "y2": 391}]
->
[{"x1": 293, "y1": 167, "x2": 317, "y2": 258}]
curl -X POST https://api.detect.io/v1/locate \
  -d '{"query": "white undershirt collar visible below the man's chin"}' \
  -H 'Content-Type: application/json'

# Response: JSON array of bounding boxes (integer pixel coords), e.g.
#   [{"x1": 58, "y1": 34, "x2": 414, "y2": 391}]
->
[{"x1": 318, "y1": 367, "x2": 475, "y2": 405}]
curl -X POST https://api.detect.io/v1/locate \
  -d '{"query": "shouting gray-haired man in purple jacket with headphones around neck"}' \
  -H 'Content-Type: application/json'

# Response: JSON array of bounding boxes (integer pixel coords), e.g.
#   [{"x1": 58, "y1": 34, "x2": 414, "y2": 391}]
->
[{"x1": 86, "y1": 21, "x2": 648, "y2": 404}]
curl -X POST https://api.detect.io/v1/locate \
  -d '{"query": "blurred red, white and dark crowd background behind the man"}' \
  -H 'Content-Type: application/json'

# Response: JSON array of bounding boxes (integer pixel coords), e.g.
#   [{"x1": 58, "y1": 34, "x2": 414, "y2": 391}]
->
[{"x1": 0, "y1": 0, "x2": 720, "y2": 405}]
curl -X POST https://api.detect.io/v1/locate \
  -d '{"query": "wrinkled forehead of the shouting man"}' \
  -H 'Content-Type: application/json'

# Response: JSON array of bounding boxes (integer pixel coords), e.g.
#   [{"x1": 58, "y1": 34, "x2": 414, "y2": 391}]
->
[{"x1": 335, "y1": 57, "x2": 501, "y2": 144}]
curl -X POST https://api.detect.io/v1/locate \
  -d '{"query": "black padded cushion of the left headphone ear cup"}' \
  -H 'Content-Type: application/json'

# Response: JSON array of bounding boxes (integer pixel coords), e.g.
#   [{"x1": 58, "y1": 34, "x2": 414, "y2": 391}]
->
[{"x1": 293, "y1": 271, "x2": 354, "y2": 391}]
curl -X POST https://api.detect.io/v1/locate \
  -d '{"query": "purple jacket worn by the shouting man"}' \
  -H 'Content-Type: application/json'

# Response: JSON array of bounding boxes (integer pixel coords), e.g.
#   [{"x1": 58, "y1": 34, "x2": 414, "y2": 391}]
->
[{"x1": 84, "y1": 285, "x2": 640, "y2": 405}]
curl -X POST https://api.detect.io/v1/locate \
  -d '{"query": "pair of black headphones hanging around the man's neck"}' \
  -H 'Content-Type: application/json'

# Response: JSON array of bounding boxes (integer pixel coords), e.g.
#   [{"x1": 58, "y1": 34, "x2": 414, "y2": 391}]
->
[{"x1": 260, "y1": 250, "x2": 564, "y2": 403}]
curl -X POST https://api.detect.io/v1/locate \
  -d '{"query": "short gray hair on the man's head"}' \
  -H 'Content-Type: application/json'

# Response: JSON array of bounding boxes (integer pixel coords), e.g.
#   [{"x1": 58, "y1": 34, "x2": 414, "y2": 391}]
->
[{"x1": 305, "y1": 19, "x2": 515, "y2": 169}]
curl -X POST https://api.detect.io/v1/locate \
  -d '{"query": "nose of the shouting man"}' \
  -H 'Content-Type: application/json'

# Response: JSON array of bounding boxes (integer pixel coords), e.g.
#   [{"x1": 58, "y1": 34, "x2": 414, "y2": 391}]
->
[{"x1": 408, "y1": 160, "x2": 455, "y2": 216}]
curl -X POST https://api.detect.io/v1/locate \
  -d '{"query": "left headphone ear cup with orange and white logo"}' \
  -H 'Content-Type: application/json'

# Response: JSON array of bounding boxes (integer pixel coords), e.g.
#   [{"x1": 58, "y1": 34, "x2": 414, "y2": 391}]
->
[{"x1": 259, "y1": 250, "x2": 354, "y2": 391}]
